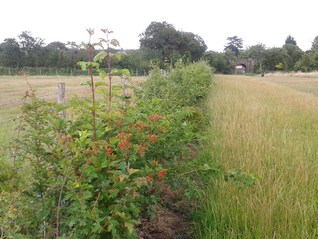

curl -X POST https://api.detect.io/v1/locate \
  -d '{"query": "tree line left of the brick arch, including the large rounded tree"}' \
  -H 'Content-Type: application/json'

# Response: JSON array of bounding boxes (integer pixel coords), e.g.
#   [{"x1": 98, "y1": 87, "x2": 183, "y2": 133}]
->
[{"x1": 0, "y1": 22, "x2": 207, "y2": 74}]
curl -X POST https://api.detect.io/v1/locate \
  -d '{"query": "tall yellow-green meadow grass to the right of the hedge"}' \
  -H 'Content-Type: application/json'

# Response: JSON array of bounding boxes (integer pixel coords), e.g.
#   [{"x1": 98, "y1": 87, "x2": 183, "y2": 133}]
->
[{"x1": 198, "y1": 76, "x2": 318, "y2": 239}]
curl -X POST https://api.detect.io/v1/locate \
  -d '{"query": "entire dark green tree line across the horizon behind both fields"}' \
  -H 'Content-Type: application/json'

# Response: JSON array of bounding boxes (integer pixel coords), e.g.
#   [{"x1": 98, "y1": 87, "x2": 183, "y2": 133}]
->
[{"x1": 0, "y1": 22, "x2": 318, "y2": 74}]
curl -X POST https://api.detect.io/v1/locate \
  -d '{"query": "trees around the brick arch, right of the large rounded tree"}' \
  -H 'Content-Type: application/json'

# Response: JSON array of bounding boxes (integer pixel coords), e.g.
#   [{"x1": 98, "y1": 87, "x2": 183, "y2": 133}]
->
[{"x1": 204, "y1": 35, "x2": 318, "y2": 73}]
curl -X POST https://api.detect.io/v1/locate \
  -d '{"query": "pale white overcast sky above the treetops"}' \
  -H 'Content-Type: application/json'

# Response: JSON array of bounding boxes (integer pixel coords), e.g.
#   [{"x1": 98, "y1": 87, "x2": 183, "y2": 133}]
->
[{"x1": 0, "y1": 0, "x2": 318, "y2": 52}]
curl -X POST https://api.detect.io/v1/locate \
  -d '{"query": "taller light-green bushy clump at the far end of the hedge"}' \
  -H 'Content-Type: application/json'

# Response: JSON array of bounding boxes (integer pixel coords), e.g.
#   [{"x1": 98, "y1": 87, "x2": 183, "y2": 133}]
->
[{"x1": 141, "y1": 61, "x2": 213, "y2": 112}]
